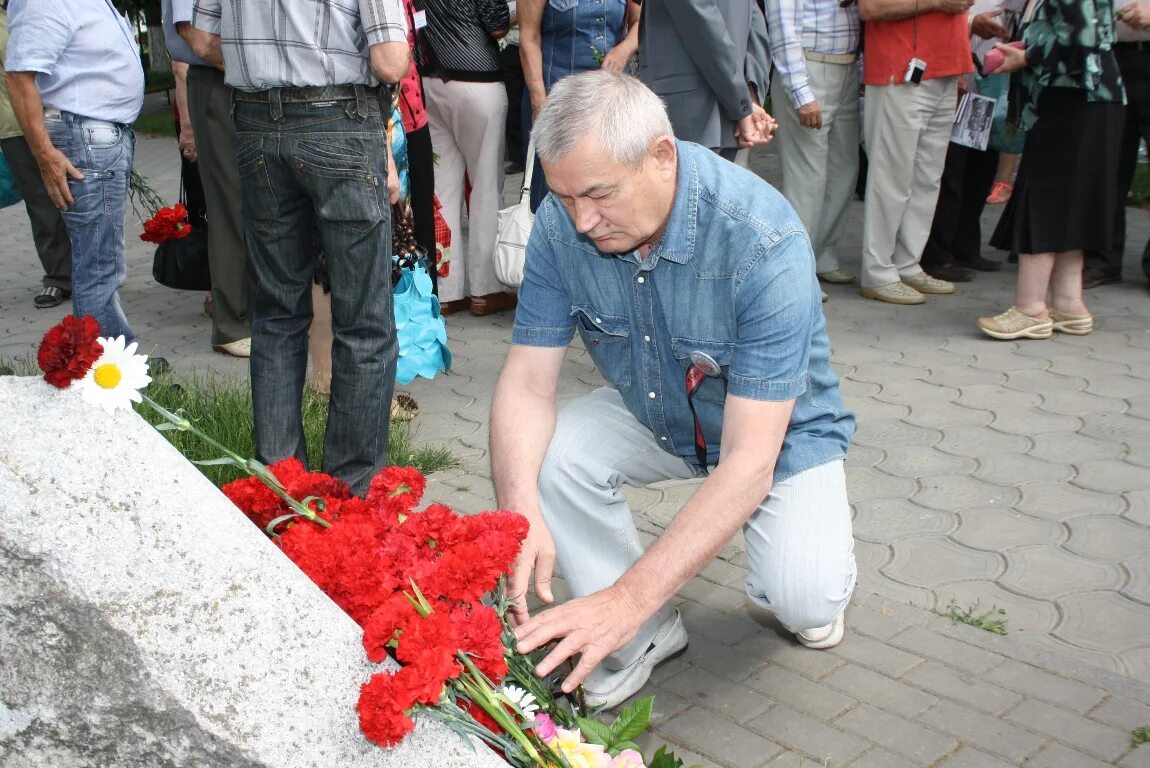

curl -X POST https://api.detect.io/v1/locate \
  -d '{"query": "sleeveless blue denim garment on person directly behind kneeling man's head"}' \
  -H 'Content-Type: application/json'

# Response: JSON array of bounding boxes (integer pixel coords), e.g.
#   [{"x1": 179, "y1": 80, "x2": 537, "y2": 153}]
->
[{"x1": 539, "y1": 0, "x2": 627, "y2": 91}]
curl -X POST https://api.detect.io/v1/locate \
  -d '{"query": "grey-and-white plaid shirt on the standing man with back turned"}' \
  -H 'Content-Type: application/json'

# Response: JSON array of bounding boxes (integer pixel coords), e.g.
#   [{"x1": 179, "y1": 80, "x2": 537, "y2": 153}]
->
[{"x1": 192, "y1": 0, "x2": 407, "y2": 91}]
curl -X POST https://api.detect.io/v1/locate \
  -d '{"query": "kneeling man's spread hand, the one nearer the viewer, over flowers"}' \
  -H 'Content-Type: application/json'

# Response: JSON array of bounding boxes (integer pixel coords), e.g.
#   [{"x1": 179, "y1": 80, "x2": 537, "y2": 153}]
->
[{"x1": 515, "y1": 586, "x2": 650, "y2": 693}]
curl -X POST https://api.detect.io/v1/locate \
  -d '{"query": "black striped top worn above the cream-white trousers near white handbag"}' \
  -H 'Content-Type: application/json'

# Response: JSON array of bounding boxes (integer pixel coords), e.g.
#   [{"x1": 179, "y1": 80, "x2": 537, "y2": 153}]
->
[{"x1": 415, "y1": 0, "x2": 511, "y2": 83}]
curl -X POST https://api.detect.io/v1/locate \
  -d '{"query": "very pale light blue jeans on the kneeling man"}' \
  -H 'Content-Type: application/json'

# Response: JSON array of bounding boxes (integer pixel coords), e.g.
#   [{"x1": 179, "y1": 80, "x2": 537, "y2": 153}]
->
[{"x1": 539, "y1": 386, "x2": 857, "y2": 669}]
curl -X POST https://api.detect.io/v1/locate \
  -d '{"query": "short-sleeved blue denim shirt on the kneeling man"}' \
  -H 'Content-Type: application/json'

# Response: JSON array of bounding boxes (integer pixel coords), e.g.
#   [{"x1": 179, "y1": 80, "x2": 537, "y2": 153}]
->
[{"x1": 512, "y1": 141, "x2": 854, "y2": 482}]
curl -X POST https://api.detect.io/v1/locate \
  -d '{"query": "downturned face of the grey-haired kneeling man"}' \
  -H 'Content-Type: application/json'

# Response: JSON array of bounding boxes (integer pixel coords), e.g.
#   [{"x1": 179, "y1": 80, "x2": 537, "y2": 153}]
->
[{"x1": 543, "y1": 133, "x2": 677, "y2": 253}]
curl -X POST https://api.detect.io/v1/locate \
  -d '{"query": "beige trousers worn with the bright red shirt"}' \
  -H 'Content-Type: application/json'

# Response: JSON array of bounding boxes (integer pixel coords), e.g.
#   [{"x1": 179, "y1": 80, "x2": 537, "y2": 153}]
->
[{"x1": 860, "y1": 77, "x2": 958, "y2": 287}]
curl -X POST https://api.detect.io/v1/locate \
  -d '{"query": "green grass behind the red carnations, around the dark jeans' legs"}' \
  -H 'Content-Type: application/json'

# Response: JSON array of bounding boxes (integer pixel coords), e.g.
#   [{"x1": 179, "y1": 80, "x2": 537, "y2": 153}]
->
[{"x1": 136, "y1": 374, "x2": 459, "y2": 485}]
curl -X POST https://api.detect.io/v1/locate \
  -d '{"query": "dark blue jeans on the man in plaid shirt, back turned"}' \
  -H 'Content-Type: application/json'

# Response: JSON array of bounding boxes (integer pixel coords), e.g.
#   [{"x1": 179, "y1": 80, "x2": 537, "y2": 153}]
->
[{"x1": 235, "y1": 85, "x2": 398, "y2": 494}]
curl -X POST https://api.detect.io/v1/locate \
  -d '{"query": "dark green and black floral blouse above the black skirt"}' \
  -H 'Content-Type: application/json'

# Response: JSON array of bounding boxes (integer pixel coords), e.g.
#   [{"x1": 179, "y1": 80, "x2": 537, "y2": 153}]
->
[{"x1": 1021, "y1": 0, "x2": 1126, "y2": 129}]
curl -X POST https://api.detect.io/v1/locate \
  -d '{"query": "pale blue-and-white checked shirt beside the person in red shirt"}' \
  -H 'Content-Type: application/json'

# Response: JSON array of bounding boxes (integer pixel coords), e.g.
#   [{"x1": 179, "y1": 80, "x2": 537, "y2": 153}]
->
[{"x1": 766, "y1": 0, "x2": 859, "y2": 107}]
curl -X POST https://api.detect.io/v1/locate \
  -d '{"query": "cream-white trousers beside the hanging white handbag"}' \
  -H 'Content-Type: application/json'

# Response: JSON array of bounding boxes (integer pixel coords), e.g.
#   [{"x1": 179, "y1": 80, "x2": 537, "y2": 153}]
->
[{"x1": 423, "y1": 77, "x2": 507, "y2": 301}]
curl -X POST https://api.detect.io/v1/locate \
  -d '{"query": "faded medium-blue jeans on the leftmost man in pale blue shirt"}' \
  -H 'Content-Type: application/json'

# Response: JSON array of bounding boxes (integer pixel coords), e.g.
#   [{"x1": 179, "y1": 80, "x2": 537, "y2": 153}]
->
[{"x1": 44, "y1": 112, "x2": 136, "y2": 341}]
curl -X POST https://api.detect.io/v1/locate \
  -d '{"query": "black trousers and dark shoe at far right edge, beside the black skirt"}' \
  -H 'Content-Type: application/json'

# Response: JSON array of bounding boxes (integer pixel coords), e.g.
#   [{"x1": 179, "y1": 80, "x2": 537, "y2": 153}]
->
[{"x1": 1086, "y1": 43, "x2": 1150, "y2": 278}]
